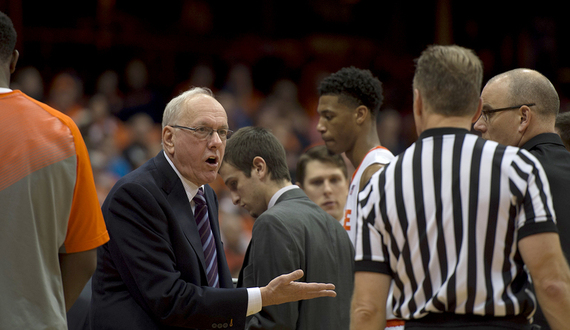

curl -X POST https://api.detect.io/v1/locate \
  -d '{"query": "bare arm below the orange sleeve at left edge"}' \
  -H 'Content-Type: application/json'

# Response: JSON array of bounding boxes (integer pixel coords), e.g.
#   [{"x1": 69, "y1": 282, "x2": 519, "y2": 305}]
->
[{"x1": 59, "y1": 249, "x2": 97, "y2": 311}]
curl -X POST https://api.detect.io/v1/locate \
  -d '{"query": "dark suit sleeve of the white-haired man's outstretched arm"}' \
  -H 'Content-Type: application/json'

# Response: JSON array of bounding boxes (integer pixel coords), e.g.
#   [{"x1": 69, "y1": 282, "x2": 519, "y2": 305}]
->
[{"x1": 103, "y1": 182, "x2": 247, "y2": 329}]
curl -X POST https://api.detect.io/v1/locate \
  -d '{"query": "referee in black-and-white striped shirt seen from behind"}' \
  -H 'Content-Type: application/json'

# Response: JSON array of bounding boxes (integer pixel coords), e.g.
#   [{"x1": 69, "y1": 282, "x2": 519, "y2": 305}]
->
[{"x1": 351, "y1": 46, "x2": 570, "y2": 330}]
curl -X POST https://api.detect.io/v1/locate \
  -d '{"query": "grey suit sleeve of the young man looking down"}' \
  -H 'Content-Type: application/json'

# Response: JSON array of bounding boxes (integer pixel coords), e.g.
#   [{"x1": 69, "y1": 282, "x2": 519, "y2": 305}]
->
[{"x1": 243, "y1": 215, "x2": 303, "y2": 329}]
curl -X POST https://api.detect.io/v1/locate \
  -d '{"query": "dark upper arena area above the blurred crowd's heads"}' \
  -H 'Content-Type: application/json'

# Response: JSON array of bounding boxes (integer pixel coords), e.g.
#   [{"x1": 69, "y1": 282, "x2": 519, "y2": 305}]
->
[{"x1": 0, "y1": 0, "x2": 570, "y2": 110}]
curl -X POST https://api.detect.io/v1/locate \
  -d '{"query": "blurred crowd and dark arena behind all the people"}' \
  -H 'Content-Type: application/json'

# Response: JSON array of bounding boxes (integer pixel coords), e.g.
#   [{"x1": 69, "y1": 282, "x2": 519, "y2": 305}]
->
[{"x1": 0, "y1": 0, "x2": 570, "y2": 276}]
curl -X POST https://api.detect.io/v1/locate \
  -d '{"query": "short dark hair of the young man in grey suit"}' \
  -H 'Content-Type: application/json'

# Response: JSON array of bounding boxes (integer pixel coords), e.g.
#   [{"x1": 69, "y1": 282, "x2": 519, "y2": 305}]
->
[{"x1": 224, "y1": 126, "x2": 291, "y2": 181}]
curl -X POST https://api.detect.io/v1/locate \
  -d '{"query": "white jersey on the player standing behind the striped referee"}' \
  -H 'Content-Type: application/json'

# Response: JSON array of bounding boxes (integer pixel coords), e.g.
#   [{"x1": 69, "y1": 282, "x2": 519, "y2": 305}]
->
[{"x1": 341, "y1": 146, "x2": 404, "y2": 330}]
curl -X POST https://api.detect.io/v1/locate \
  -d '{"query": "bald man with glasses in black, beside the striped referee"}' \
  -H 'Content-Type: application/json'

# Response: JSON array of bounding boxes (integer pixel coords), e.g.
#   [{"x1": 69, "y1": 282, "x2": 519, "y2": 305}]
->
[{"x1": 474, "y1": 69, "x2": 570, "y2": 329}]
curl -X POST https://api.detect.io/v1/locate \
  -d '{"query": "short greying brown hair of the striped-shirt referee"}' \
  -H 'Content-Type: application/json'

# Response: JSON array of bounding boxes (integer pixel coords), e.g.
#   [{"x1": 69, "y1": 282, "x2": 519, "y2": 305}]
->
[{"x1": 413, "y1": 45, "x2": 483, "y2": 116}]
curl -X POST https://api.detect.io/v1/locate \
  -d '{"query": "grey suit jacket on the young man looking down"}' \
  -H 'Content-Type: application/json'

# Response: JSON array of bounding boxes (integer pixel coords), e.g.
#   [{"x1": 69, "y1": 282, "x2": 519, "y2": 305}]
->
[{"x1": 238, "y1": 189, "x2": 354, "y2": 330}]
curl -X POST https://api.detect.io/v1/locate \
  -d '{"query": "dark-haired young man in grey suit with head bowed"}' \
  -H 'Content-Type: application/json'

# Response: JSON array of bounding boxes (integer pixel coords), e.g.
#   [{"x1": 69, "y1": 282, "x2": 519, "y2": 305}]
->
[{"x1": 220, "y1": 127, "x2": 354, "y2": 329}]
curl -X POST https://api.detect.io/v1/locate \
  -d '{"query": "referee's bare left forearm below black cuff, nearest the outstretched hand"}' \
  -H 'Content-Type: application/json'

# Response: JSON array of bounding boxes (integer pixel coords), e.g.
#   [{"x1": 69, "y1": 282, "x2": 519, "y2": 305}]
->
[{"x1": 350, "y1": 271, "x2": 392, "y2": 330}]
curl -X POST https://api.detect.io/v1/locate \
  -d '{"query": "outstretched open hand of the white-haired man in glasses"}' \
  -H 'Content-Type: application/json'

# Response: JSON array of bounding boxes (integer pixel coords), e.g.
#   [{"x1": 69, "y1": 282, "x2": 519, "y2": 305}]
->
[{"x1": 261, "y1": 269, "x2": 336, "y2": 307}]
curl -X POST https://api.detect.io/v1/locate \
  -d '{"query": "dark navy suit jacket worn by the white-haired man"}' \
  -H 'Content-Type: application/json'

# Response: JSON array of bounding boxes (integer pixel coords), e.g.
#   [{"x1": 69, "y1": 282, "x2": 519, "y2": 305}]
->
[{"x1": 90, "y1": 151, "x2": 248, "y2": 330}]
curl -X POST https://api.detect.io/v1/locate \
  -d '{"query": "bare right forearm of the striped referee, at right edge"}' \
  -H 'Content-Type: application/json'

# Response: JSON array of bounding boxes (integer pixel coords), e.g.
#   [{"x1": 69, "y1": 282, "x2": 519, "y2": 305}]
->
[{"x1": 518, "y1": 232, "x2": 570, "y2": 330}]
